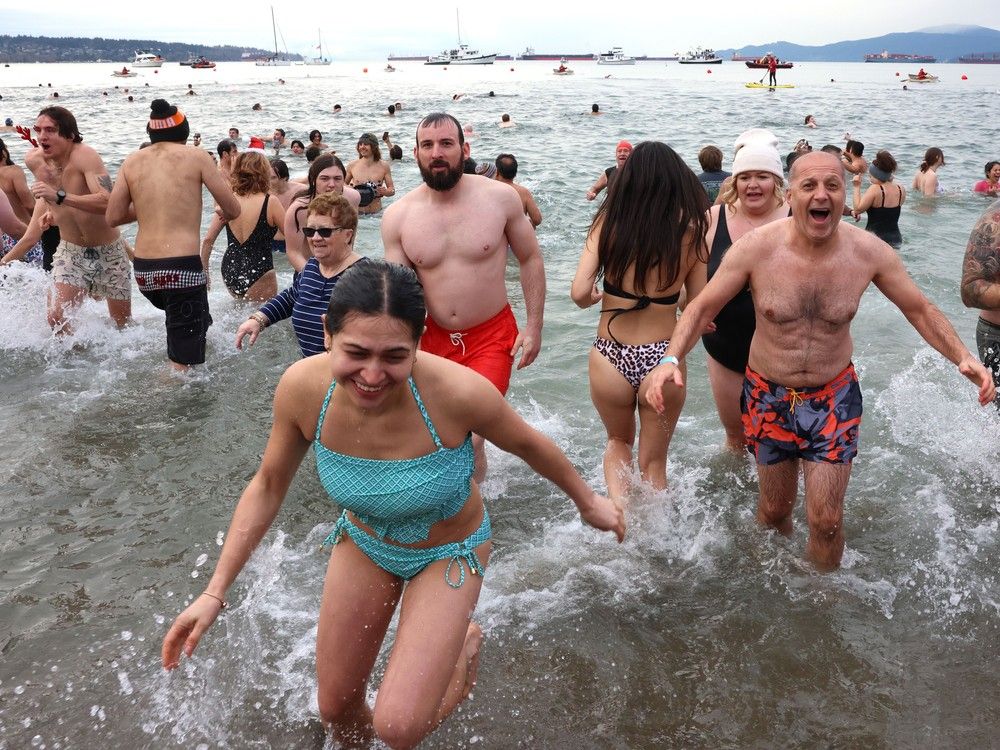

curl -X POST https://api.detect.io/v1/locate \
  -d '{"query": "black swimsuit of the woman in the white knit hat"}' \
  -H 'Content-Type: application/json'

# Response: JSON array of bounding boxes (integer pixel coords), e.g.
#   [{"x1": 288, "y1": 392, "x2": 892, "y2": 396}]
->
[{"x1": 701, "y1": 206, "x2": 757, "y2": 375}]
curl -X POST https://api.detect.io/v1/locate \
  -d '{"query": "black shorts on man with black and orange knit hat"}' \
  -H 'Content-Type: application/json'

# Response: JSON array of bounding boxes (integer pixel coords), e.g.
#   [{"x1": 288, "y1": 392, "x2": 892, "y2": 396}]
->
[{"x1": 134, "y1": 255, "x2": 212, "y2": 365}]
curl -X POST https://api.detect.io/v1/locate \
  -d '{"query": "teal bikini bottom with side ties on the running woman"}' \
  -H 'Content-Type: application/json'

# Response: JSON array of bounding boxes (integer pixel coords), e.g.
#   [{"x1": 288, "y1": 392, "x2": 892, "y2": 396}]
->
[{"x1": 323, "y1": 508, "x2": 493, "y2": 589}]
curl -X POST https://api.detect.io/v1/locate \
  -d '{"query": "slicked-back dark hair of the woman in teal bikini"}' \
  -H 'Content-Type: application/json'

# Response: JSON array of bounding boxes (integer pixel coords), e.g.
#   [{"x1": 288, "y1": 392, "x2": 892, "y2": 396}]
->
[{"x1": 324, "y1": 259, "x2": 427, "y2": 343}]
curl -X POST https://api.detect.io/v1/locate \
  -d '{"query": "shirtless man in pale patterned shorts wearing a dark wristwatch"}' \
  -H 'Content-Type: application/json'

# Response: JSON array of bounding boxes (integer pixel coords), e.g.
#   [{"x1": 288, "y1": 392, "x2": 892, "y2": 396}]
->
[{"x1": 12, "y1": 106, "x2": 132, "y2": 334}]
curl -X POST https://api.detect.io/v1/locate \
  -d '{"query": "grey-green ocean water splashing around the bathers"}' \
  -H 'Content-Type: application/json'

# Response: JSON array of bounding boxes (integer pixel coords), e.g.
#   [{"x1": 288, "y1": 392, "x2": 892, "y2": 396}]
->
[{"x1": 0, "y1": 61, "x2": 1000, "y2": 748}]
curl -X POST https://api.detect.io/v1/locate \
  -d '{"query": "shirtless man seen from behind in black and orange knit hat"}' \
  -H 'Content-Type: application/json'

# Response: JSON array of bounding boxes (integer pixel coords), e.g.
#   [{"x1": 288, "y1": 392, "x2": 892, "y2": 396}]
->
[{"x1": 106, "y1": 99, "x2": 240, "y2": 370}]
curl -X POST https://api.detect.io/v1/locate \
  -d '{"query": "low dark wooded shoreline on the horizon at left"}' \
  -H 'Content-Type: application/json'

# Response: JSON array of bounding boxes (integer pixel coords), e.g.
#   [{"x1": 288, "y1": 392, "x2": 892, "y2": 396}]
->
[{"x1": 0, "y1": 34, "x2": 292, "y2": 63}]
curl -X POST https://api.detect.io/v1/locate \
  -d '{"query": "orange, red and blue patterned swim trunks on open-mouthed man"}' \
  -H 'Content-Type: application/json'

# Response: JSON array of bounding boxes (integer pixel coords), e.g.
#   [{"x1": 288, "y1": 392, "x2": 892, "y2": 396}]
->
[{"x1": 740, "y1": 364, "x2": 862, "y2": 465}]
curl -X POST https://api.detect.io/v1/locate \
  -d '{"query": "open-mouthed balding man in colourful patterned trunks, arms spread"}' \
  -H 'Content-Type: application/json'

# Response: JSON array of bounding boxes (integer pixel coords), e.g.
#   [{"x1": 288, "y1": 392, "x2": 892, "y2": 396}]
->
[{"x1": 647, "y1": 151, "x2": 996, "y2": 569}]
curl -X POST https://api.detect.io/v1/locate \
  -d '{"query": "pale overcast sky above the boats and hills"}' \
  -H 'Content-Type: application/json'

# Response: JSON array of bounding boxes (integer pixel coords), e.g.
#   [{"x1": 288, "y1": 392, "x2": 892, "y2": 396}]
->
[{"x1": 0, "y1": 0, "x2": 1000, "y2": 59}]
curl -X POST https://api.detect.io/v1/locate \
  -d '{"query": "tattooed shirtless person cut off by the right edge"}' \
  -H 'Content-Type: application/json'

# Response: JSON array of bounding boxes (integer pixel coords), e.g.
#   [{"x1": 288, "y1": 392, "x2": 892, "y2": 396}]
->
[{"x1": 962, "y1": 195, "x2": 1000, "y2": 408}]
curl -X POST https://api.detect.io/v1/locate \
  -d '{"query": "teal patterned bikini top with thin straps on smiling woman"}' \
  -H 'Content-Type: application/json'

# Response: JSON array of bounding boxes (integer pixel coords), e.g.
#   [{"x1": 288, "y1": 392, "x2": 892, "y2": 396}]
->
[{"x1": 313, "y1": 377, "x2": 474, "y2": 544}]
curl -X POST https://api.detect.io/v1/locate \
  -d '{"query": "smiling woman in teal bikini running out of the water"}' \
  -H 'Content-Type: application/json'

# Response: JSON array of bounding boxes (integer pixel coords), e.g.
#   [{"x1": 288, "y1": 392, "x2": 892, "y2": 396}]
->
[{"x1": 162, "y1": 261, "x2": 625, "y2": 747}]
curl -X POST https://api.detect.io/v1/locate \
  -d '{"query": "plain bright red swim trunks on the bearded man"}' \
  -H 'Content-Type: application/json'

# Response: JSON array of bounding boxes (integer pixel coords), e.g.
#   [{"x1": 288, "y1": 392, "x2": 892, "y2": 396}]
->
[{"x1": 420, "y1": 305, "x2": 517, "y2": 395}]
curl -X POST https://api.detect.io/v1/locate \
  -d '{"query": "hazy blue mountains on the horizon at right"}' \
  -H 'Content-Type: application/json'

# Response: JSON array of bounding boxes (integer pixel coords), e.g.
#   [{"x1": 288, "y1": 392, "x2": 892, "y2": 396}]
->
[{"x1": 716, "y1": 26, "x2": 1000, "y2": 62}]
